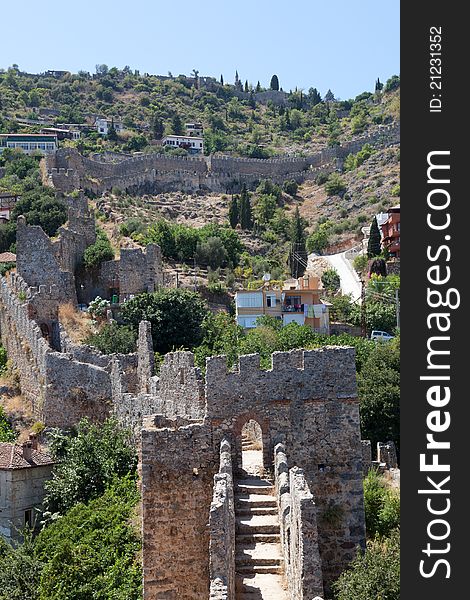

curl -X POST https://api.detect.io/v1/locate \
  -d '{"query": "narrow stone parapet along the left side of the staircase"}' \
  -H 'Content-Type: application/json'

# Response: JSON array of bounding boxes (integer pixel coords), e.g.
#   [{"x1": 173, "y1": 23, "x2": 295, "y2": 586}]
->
[{"x1": 209, "y1": 440, "x2": 235, "y2": 600}]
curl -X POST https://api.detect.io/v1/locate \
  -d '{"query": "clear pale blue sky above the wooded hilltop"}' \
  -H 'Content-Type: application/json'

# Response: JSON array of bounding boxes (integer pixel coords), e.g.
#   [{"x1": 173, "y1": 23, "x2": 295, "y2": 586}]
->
[{"x1": 0, "y1": 0, "x2": 400, "y2": 99}]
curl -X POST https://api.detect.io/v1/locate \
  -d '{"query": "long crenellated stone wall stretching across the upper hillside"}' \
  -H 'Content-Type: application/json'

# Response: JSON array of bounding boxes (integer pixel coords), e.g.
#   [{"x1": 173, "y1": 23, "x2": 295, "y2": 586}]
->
[{"x1": 46, "y1": 123, "x2": 400, "y2": 195}]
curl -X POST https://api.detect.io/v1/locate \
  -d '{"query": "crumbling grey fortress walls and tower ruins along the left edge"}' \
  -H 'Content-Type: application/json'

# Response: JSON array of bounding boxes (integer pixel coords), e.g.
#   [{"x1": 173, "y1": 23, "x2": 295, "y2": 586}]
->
[{"x1": 0, "y1": 196, "x2": 163, "y2": 427}]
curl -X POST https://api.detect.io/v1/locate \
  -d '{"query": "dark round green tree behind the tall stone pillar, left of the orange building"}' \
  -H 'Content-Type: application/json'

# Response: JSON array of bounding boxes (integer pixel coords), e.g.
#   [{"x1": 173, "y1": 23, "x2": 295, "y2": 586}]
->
[{"x1": 121, "y1": 289, "x2": 207, "y2": 354}]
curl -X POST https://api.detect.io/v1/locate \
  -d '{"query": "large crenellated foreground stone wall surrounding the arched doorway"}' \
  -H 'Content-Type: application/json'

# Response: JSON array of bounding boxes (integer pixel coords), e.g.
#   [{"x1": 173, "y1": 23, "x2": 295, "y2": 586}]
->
[{"x1": 121, "y1": 338, "x2": 365, "y2": 600}]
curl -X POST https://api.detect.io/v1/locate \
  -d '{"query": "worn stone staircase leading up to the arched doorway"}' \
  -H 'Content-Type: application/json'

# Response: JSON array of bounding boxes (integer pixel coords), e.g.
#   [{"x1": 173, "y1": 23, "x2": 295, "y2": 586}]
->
[{"x1": 234, "y1": 460, "x2": 288, "y2": 600}]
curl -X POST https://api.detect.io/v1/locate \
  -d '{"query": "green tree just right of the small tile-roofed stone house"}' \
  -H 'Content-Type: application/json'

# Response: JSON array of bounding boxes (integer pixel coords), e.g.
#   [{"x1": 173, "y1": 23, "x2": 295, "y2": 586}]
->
[{"x1": 44, "y1": 419, "x2": 137, "y2": 514}]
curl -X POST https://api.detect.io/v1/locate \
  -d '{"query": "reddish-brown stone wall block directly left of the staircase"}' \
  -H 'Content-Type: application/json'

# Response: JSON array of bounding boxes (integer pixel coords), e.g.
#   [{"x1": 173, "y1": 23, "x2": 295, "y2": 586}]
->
[{"x1": 140, "y1": 416, "x2": 219, "y2": 600}]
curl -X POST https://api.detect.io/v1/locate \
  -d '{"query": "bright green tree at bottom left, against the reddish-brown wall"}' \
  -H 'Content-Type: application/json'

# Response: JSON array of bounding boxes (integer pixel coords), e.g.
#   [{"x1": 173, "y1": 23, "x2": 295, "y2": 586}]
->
[{"x1": 35, "y1": 478, "x2": 142, "y2": 600}]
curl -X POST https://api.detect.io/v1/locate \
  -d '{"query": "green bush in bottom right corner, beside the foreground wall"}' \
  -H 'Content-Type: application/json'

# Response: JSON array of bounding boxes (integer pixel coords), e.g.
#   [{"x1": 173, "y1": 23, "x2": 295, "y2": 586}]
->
[{"x1": 333, "y1": 530, "x2": 400, "y2": 600}]
